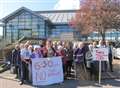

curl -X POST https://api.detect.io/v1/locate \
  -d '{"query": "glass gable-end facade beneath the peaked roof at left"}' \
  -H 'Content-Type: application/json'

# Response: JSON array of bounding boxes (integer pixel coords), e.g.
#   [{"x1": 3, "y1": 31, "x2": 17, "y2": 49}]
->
[{"x1": 5, "y1": 12, "x2": 45, "y2": 42}]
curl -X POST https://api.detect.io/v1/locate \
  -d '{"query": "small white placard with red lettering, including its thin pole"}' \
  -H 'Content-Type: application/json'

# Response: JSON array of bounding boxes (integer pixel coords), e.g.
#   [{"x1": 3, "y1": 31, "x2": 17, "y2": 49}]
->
[{"x1": 93, "y1": 48, "x2": 108, "y2": 85}]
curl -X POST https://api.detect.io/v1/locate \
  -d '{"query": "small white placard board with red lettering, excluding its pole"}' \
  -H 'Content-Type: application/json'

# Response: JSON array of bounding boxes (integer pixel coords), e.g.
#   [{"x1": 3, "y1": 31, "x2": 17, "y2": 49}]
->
[{"x1": 93, "y1": 48, "x2": 108, "y2": 61}]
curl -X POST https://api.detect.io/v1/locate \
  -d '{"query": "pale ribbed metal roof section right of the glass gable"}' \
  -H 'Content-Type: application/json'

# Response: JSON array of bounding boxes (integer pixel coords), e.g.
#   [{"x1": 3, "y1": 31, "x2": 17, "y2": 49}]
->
[{"x1": 34, "y1": 10, "x2": 77, "y2": 23}]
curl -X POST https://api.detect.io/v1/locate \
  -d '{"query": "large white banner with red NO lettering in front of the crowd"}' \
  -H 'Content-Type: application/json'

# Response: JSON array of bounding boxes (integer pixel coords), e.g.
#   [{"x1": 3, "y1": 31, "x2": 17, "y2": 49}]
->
[{"x1": 32, "y1": 57, "x2": 64, "y2": 85}]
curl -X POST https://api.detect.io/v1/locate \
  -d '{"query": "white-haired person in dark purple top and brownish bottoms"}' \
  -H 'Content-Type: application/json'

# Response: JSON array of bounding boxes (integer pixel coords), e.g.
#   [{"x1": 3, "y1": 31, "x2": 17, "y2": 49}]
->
[{"x1": 74, "y1": 42, "x2": 87, "y2": 80}]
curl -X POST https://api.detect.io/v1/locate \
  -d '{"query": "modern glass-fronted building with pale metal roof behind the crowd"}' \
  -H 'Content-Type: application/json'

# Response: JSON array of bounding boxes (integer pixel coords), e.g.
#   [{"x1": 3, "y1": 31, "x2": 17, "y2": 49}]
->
[{"x1": 2, "y1": 7, "x2": 120, "y2": 43}]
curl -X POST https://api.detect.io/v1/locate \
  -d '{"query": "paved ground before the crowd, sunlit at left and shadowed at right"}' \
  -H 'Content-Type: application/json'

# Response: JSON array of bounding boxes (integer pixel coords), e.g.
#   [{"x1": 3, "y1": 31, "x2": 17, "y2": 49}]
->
[{"x1": 0, "y1": 60, "x2": 120, "y2": 88}]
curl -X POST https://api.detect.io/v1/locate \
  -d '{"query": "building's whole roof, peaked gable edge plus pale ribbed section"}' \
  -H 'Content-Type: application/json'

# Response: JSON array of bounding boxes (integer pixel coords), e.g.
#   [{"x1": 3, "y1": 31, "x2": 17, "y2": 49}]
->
[{"x1": 2, "y1": 7, "x2": 78, "y2": 24}]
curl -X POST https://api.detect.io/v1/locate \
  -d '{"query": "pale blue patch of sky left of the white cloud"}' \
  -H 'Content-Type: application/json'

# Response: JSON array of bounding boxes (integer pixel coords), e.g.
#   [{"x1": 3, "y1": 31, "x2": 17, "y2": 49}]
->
[{"x1": 0, "y1": 0, "x2": 58, "y2": 19}]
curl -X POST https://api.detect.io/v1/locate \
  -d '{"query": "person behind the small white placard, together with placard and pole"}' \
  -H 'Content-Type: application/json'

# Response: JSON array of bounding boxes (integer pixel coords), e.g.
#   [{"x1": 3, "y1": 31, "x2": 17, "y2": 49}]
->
[{"x1": 93, "y1": 40, "x2": 108, "y2": 85}]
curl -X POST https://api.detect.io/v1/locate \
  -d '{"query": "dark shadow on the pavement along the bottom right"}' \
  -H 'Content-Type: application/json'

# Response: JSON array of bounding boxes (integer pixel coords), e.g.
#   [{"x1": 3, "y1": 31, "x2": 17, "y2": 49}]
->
[{"x1": 31, "y1": 79, "x2": 120, "y2": 88}]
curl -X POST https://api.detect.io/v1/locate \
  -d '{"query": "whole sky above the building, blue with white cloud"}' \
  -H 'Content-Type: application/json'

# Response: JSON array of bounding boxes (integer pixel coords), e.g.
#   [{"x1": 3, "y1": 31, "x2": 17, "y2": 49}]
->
[{"x1": 0, "y1": 0, "x2": 79, "y2": 35}]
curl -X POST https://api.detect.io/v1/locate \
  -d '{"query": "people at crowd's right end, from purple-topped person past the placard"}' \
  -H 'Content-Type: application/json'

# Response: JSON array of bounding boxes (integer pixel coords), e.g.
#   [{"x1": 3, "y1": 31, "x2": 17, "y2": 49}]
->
[{"x1": 73, "y1": 40, "x2": 114, "y2": 80}]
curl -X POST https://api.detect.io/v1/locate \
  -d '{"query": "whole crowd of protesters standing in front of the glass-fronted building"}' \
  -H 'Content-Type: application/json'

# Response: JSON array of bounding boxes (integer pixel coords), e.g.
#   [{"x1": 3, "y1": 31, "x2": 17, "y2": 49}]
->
[{"x1": 11, "y1": 40, "x2": 113, "y2": 84}]
